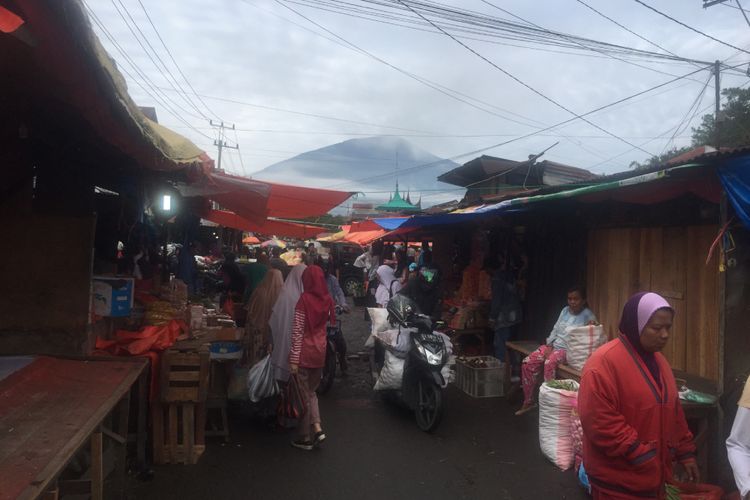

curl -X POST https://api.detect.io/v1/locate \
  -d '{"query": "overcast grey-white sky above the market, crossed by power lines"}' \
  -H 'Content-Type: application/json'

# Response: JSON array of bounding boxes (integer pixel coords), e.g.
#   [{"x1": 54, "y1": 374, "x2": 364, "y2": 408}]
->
[{"x1": 87, "y1": 0, "x2": 750, "y2": 192}]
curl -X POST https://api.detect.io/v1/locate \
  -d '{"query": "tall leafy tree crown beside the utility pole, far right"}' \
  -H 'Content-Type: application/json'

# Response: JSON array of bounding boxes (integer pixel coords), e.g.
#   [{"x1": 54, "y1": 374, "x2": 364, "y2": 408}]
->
[{"x1": 693, "y1": 87, "x2": 750, "y2": 148}]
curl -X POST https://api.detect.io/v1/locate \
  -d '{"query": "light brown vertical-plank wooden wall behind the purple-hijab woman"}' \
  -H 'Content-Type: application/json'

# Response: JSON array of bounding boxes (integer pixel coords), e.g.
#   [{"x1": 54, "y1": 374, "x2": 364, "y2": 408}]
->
[{"x1": 587, "y1": 225, "x2": 720, "y2": 381}]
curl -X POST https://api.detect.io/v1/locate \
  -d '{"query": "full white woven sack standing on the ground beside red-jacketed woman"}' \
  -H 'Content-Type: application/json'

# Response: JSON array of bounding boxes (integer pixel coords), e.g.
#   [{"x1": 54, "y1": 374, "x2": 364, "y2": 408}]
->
[{"x1": 539, "y1": 380, "x2": 578, "y2": 470}]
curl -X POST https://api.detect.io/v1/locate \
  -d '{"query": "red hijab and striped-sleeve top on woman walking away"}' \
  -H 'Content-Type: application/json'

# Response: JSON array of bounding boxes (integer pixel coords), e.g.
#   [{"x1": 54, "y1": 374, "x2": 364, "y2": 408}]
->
[{"x1": 295, "y1": 266, "x2": 336, "y2": 368}]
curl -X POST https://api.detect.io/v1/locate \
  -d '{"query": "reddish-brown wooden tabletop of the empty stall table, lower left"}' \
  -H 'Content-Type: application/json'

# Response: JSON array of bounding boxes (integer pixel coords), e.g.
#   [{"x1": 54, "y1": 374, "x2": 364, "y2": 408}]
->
[{"x1": 0, "y1": 357, "x2": 147, "y2": 498}]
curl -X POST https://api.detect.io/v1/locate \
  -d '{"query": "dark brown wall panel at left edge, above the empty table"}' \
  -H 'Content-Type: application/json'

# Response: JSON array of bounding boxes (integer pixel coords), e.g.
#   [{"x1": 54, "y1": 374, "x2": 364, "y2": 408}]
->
[{"x1": 0, "y1": 215, "x2": 95, "y2": 355}]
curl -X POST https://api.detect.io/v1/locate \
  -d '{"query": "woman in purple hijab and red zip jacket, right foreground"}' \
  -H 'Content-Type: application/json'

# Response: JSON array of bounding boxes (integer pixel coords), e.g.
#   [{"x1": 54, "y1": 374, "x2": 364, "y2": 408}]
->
[{"x1": 578, "y1": 292, "x2": 698, "y2": 499}]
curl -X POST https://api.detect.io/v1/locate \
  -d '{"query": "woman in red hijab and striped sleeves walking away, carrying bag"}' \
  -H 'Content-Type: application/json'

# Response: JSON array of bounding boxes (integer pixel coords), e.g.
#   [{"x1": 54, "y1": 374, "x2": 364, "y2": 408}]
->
[{"x1": 289, "y1": 266, "x2": 336, "y2": 450}]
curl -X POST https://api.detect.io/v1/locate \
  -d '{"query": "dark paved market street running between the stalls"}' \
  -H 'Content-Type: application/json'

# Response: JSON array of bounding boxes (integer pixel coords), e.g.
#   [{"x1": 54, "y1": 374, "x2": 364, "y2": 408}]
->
[{"x1": 128, "y1": 304, "x2": 586, "y2": 500}]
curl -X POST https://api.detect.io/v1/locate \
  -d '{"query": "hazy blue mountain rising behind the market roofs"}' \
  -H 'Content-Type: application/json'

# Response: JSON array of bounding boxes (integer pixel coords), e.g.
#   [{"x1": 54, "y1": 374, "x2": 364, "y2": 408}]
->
[{"x1": 253, "y1": 137, "x2": 463, "y2": 207}]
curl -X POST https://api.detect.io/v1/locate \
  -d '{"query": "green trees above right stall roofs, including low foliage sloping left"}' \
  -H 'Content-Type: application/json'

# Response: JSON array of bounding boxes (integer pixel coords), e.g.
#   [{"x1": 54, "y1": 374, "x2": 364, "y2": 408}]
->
[{"x1": 630, "y1": 87, "x2": 750, "y2": 170}]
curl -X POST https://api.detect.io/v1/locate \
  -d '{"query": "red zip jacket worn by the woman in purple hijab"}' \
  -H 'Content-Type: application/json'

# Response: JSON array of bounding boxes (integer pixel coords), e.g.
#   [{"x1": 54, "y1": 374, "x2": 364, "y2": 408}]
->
[{"x1": 578, "y1": 336, "x2": 695, "y2": 498}]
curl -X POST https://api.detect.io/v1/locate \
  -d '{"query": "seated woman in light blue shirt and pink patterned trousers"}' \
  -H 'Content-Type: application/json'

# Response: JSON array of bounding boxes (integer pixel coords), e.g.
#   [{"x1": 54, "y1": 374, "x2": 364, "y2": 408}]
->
[{"x1": 516, "y1": 286, "x2": 596, "y2": 415}]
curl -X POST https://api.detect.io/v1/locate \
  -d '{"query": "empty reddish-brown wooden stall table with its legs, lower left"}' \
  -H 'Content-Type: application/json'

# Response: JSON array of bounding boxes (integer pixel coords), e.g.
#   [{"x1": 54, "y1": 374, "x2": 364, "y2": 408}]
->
[{"x1": 0, "y1": 356, "x2": 148, "y2": 500}]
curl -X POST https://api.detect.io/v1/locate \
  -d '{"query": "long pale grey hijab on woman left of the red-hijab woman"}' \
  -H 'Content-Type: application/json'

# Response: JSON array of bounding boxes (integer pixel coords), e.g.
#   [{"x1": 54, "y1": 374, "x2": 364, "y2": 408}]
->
[{"x1": 268, "y1": 264, "x2": 307, "y2": 382}]
